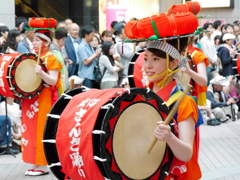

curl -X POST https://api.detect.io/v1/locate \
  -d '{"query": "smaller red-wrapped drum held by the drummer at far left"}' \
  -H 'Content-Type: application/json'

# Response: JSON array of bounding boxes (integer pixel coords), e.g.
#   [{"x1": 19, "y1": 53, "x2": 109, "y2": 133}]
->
[{"x1": 0, "y1": 53, "x2": 46, "y2": 99}]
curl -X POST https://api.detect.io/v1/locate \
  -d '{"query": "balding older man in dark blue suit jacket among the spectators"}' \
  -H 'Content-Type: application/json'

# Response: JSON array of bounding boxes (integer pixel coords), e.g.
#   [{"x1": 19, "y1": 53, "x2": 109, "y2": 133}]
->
[{"x1": 65, "y1": 23, "x2": 80, "y2": 76}]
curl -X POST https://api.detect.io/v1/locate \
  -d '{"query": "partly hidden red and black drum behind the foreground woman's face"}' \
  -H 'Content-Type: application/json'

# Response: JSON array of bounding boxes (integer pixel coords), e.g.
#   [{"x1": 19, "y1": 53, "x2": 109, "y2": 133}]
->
[{"x1": 128, "y1": 50, "x2": 191, "y2": 88}]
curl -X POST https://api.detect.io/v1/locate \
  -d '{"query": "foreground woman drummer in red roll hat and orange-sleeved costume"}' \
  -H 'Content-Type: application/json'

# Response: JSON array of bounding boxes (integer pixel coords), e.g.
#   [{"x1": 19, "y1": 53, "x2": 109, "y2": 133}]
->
[{"x1": 125, "y1": 1, "x2": 202, "y2": 180}]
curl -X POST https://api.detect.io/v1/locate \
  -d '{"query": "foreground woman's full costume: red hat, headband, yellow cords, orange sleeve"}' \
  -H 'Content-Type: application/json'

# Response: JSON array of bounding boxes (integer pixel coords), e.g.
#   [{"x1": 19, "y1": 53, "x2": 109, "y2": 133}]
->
[{"x1": 125, "y1": 2, "x2": 204, "y2": 180}]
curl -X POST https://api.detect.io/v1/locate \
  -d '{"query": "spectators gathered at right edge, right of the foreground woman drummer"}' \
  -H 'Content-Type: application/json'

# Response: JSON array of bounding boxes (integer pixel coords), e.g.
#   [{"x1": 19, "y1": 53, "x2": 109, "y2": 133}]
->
[{"x1": 196, "y1": 20, "x2": 240, "y2": 126}]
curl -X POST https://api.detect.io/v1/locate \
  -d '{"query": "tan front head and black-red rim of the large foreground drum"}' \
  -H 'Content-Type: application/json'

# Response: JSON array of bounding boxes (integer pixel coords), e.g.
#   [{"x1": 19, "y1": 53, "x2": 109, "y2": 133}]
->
[{"x1": 98, "y1": 88, "x2": 168, "y2": 180}]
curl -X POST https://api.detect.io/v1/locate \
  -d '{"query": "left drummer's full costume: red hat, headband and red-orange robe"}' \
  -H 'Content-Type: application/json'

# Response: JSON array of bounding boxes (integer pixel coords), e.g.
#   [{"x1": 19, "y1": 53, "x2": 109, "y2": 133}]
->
[{"x1": 22, "y1": 18, "x2": 62, "y2": 165}]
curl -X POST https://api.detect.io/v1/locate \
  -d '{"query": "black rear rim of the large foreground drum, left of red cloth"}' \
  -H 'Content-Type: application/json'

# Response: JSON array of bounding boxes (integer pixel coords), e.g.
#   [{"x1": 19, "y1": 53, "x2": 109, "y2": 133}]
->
[{"x1": 43, "y1": 88, "x2": 85, "y2": 180}]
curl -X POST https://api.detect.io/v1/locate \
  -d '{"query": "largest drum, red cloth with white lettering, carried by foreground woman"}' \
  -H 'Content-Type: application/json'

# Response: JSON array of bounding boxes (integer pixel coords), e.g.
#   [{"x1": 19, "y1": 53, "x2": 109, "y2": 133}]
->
[{"x1": 44, "y1": 88, "x2": 170, "y2": 180}]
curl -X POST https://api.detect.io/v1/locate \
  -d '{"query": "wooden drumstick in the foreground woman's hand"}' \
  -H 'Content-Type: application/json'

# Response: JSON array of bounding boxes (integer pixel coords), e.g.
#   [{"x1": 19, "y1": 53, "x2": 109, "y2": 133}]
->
[{"x1": 147, "y1": 84, "x2": 192, "y2": 153}]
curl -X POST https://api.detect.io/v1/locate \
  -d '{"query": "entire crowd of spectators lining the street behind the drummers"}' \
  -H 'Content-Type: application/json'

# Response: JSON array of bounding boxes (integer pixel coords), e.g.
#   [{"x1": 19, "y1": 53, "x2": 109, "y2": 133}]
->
[{"x1": 0, "y1": 17, "x2": 240, "y2": 167}]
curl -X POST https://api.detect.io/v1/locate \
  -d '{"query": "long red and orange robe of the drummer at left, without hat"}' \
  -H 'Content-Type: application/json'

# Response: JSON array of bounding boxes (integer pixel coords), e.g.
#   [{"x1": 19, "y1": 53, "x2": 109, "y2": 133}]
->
[{"x1": 22, "y1": 50, "x2": 61, "y2": 165}]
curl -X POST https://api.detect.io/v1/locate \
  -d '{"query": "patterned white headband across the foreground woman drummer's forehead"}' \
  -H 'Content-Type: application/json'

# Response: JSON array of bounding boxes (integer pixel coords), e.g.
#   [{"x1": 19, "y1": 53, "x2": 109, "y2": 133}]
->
[{"x1": 147, "y1": 41, "x2": 181, "y2": 62}]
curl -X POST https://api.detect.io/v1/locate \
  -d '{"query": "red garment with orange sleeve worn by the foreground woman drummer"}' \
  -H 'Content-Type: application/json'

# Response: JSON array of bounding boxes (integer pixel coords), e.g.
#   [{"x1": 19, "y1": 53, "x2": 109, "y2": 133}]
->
[{"x1": 153, "y1": 81, "x2": 202, "y2": 180}]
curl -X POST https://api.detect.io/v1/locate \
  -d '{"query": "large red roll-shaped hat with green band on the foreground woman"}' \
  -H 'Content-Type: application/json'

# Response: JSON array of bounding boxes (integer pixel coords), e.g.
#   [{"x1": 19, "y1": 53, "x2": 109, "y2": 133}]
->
[{"x1": 124, "y1": 2, "x2": 201, "y2": 39}]
